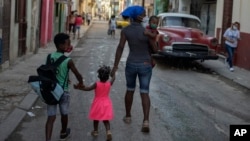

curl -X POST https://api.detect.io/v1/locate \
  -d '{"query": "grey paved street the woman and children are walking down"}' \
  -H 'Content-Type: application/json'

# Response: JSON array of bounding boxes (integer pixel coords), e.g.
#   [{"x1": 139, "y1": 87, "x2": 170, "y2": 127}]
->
[{"x1": 7, "y1": 21, "x2": 250, "y2": 141}]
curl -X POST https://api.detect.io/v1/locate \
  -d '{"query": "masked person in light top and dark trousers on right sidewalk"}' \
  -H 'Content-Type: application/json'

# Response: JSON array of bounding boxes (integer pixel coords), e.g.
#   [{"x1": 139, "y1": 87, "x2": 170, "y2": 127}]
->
[{"x1": 223, "y1": 22, "x2": 240, "y2": 71}]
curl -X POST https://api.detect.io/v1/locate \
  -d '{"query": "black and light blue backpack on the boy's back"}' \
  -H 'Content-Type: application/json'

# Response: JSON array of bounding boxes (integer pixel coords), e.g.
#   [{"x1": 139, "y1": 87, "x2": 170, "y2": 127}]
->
[{"x1": 28, "y1": 54, "x2": 68, "y2": 105}]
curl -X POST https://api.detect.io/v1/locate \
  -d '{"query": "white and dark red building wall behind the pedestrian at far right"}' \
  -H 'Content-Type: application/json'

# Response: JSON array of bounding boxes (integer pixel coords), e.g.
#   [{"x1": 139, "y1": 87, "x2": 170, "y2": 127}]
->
[{"x1": 215, "y1": 0, "x2": 250, "y2": 70}]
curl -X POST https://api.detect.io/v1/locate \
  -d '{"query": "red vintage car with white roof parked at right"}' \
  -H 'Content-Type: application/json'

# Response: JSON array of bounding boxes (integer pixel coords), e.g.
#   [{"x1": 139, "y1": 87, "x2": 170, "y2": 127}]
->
[{"x1": 157, "y1": 13, "x2": 218, "y2": 60}]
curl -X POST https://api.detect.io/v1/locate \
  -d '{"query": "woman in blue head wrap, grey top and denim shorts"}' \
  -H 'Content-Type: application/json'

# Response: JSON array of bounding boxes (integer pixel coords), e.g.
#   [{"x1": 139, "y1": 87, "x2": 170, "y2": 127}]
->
[{"x1": 111, "y1": 6, "x2": 156, "y2": 132}]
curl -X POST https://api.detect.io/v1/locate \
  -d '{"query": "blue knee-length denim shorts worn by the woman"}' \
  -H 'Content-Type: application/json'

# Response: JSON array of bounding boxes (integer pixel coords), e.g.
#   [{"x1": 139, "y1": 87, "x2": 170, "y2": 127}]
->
[{"x1": 125, "y1": 62, "x2": 152, "y2": 94}]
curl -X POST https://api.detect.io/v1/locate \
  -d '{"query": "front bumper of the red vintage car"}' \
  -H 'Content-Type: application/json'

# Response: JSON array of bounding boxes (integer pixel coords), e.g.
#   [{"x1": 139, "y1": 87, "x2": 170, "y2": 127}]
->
[{"x1": 158, "y1": 51, "x2": 219, "y2": 60}]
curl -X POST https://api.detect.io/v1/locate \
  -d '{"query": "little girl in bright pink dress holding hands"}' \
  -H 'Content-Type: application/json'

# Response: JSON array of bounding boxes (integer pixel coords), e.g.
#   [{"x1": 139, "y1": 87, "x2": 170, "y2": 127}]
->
[{"x1": 74, "y1": 66, "x2": 115, "y2": 141}]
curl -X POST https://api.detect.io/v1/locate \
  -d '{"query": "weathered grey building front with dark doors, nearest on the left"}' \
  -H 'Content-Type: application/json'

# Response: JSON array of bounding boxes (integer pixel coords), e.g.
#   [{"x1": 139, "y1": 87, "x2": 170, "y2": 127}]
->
[{"x1": 0, "y1": 0, "x2": 41, "y2": 70}]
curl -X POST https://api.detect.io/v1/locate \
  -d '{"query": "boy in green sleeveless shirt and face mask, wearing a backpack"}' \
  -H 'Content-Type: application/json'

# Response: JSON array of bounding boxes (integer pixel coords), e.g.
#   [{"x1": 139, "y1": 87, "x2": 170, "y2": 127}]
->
[{"x1": 45, "y1": 33, "x2": 83, "y2": 141}]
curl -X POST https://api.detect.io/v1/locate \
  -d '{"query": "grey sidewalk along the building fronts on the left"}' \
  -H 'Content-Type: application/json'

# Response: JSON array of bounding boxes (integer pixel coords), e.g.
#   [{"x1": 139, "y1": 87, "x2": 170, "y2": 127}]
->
[{"x1": 0, "y1": 23, "x2": 92, "y2": 141}]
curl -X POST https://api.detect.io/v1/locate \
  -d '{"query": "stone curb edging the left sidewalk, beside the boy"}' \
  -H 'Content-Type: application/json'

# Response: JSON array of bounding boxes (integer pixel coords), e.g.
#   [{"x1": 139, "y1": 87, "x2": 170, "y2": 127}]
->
[{"x1": 0, "y1": 22, "x2": 92, "y2": 141}]
